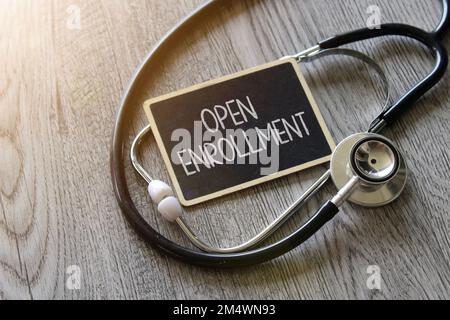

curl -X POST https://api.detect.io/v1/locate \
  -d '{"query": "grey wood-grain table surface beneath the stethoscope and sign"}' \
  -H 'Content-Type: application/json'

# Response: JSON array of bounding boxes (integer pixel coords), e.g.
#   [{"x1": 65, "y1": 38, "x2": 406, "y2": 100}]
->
[{"x1": 0, "y1": 0, "x2": 450, "y2": 299}]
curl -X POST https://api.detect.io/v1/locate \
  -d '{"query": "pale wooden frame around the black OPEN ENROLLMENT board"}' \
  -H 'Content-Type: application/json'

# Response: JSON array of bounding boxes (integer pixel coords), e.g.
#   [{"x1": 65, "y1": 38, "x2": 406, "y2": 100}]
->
[{"x1": 144, "y1": 58, "x2": 336, "y2": 207}]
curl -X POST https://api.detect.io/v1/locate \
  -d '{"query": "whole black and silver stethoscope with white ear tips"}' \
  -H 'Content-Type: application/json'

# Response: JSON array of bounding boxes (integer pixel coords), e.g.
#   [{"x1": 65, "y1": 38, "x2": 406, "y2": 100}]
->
[{"x1": 111, "y1": 0, "x2": 449, "y2": 267}]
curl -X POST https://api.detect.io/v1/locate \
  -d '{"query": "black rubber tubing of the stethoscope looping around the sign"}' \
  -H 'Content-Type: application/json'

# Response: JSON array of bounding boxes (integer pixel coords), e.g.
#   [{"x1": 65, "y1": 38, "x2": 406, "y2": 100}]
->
[{"x1": 111, "y1": 0, "x2": 449, "y2": 268}]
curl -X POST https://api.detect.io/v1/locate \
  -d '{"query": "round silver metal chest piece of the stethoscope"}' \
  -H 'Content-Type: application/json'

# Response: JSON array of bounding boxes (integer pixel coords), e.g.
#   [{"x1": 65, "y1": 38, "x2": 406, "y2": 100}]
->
[{"x1": 331, "y1": 133, "x2": 407, "y2": 207}]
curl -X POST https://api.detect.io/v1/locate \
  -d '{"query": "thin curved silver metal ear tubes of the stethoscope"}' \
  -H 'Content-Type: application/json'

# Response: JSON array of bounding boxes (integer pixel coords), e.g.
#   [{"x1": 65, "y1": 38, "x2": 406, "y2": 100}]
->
[{"x1": 130, "y1": 46, "x2": 390, "y2": 254}]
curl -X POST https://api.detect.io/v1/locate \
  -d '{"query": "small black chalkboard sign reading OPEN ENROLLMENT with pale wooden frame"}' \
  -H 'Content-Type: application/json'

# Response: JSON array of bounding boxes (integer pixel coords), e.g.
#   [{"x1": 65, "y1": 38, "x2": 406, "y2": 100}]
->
[{"x1": 144, "y1": 59, "x2": 335, "y2": 206}]
